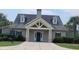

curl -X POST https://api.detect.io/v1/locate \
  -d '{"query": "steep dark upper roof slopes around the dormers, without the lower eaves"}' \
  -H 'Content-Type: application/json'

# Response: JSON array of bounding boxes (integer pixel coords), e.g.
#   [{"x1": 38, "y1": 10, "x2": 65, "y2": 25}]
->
[{"x1": 14, "y1": 14, "x2": 63, "y2": 25}]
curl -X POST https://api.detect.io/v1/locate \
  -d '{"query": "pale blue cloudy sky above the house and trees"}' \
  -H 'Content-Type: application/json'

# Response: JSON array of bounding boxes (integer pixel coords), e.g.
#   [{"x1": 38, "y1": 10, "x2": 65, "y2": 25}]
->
[{"x1": 0, "y1": 9, "x2": 79, "y2": 24}]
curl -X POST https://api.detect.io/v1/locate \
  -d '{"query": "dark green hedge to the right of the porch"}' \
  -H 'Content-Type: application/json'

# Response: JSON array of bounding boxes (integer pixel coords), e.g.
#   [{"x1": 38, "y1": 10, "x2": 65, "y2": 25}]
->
[{"x1": 52, "y1": 37, "x2": 79, "y2": 44}]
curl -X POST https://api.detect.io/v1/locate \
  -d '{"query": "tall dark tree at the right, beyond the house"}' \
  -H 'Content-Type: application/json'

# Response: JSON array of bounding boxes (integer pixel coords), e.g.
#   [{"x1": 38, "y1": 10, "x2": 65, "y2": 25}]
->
[{"x1": 65, "y1": 16, "x2": 79, "y2": 38}]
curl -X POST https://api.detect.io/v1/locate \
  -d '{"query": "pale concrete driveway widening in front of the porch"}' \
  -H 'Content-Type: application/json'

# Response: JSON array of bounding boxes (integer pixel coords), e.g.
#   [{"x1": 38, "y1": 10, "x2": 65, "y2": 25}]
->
[{"x1": 0, "y1": 42, "x2": 69, "y2": 50}]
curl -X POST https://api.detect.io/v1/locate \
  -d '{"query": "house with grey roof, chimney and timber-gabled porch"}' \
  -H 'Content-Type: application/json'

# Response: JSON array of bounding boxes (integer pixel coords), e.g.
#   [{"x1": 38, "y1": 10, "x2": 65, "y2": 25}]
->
[{"x1": 2, "y1": 9, "x2": 67, "y2": 42}]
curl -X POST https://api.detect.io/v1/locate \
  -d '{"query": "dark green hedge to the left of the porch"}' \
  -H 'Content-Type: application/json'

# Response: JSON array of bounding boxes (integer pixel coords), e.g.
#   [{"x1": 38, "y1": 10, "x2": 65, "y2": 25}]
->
[{"x1": 0, "y1": 34, "x2": 25, "y2": 41}]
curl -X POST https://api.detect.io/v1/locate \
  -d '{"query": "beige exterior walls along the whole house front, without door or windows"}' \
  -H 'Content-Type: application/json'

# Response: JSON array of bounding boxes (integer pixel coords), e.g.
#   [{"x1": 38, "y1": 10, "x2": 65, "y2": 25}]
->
[{"x1": 2, "y1": 29, "x2": 67, "y2": 42}]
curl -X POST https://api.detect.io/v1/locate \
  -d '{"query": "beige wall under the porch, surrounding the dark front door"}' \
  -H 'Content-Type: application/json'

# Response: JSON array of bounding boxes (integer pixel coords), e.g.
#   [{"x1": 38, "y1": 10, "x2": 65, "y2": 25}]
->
[{"x1": 29, "y1": 30, "x2": 48, "y2": 42}]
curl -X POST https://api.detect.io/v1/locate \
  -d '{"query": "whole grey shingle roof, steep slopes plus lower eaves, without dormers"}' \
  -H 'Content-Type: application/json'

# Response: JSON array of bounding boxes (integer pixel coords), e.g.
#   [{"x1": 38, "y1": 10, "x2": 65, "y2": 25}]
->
[{"x1": 6, "y1": 14, "x2": 67, "y2": 30}]
